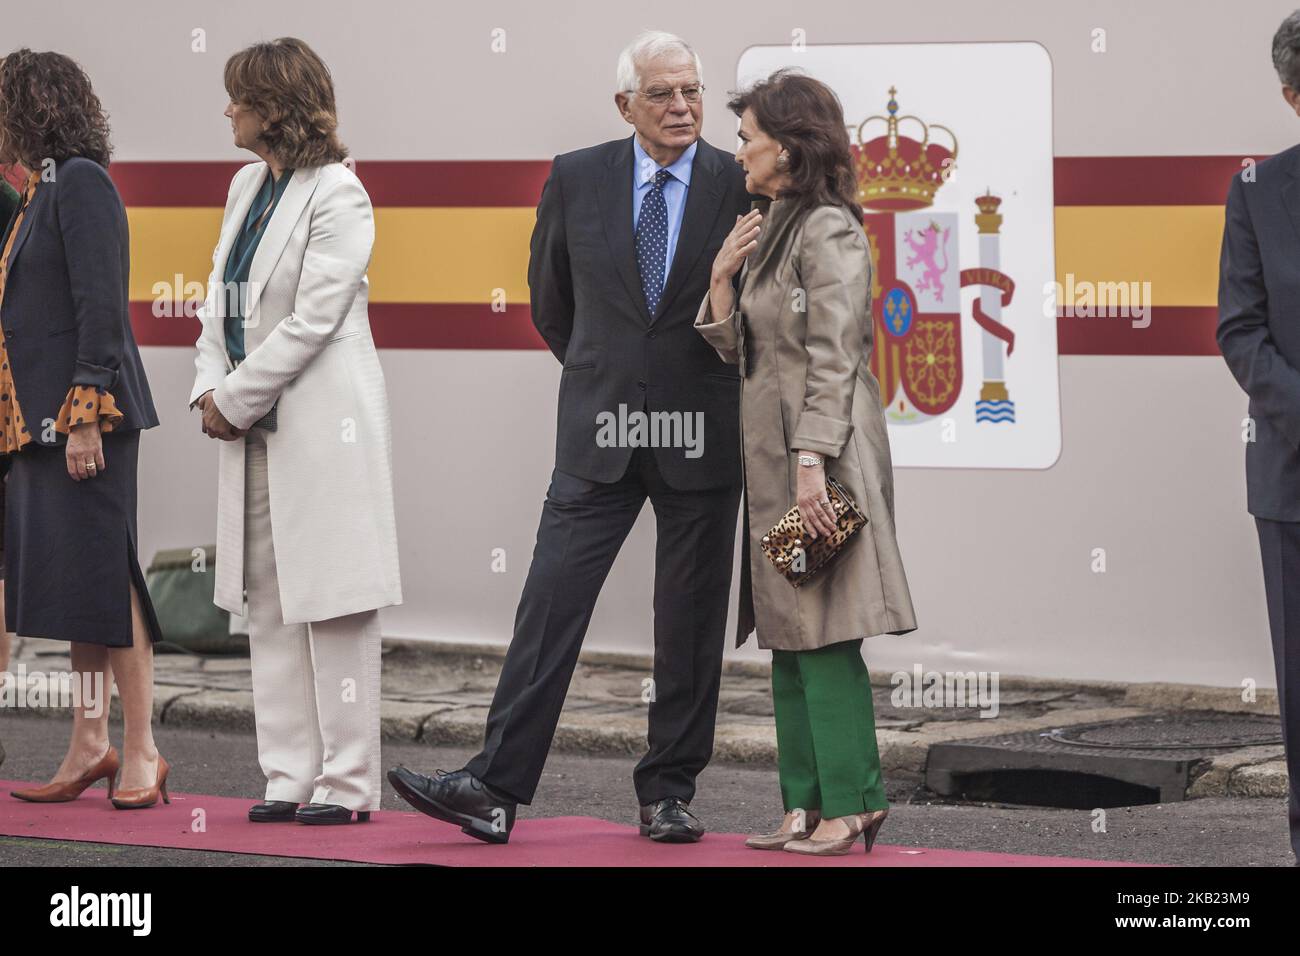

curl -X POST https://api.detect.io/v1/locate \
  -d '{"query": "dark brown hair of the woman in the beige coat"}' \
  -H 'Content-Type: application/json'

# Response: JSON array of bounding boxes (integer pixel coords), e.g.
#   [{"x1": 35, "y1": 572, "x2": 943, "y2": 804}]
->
[{"x1": 727, "y1": 68, "x2": 862, "y2": 220}]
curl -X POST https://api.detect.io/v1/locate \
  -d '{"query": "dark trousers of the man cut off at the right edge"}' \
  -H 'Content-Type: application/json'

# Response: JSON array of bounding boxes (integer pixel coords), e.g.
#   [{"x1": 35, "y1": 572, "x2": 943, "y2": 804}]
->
[{"x1": 1255, "y1": 518, "x2": 1300, "y2": 857}]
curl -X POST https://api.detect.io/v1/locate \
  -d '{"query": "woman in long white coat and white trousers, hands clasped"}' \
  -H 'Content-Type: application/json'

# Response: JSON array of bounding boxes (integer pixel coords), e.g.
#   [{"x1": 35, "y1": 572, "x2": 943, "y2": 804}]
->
[{"x1": 190, "y1": 39, "x2": 402, "y2": 823}]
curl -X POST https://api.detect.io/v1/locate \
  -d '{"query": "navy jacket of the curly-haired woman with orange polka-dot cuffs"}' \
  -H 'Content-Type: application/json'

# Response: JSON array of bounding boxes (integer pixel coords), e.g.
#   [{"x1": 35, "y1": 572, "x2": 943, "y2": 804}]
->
[{"x1": 0, "y1": 157, "x2": 159, "y2": 445}]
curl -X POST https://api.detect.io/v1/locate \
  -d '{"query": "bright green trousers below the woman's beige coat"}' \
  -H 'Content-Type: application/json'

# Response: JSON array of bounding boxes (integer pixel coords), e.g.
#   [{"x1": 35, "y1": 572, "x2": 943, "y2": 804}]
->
[{"x1": 772, "y1": 639, "x2": 889, "y2": 818}]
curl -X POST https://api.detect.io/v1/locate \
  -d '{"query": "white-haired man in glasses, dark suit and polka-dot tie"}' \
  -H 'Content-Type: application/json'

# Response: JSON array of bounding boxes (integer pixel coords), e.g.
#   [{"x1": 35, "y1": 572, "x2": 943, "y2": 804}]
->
[{"x1": 389, "y1": 33, "x2": 749, "y2": 843}]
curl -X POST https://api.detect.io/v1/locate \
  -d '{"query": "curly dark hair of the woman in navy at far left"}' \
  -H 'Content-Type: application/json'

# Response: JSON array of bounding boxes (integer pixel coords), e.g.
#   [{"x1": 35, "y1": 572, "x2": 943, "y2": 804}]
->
[{"x1": 0, "y1": 48, "x2": 113, "y2": 169}]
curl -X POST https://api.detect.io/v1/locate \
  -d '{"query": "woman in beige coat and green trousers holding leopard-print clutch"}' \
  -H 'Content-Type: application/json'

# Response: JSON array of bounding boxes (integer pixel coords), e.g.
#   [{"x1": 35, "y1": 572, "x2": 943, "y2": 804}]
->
[{"x1": 696, "y1": 70, "x2": 917, "y2": 855}]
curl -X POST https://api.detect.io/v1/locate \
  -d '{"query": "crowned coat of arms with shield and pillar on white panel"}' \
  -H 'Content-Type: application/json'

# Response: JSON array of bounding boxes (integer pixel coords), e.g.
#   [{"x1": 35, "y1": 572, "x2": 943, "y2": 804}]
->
[{"x1": 849, "y1": 86, "x2": 1015, "y2": 424}]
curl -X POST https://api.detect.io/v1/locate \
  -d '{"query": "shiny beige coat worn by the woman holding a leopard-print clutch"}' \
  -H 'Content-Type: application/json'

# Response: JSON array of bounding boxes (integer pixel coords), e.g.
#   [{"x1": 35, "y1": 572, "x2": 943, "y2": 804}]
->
[{"x1": 696, "y1": 199, "x2": 917, "y2": 650}]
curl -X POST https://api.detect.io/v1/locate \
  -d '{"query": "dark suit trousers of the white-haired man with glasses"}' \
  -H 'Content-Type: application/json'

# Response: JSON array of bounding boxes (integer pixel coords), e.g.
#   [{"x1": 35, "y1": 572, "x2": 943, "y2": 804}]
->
[{"x1": 467, "y1": 447, "x2": 740, "y2": 805}]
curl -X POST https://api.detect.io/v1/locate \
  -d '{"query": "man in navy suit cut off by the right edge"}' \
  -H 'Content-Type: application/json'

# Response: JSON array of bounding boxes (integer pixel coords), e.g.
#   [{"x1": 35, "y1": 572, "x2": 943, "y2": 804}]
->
[{"x1": 1218, "y1": 10, "x2": 1300, "y2": 862}]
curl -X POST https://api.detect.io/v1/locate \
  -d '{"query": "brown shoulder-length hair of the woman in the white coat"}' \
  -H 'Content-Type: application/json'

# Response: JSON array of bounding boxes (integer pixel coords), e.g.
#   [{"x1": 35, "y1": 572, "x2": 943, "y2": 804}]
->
[{"x1": 225, "y1": 36, "x2": 347, "y2": 169}]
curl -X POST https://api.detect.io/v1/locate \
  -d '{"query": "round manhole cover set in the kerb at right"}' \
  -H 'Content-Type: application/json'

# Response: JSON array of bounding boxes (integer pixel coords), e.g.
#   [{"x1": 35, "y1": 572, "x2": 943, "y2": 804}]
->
[{"x1": 1048, "y1": 713, "x2": 1282, "y2": 750}]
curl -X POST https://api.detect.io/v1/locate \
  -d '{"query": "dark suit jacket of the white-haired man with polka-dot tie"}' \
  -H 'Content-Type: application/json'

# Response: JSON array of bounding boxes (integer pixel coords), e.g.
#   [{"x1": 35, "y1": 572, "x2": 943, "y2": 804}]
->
[{"x1": 528, "y1": 137, "x2": 750, "y2": 490}]
